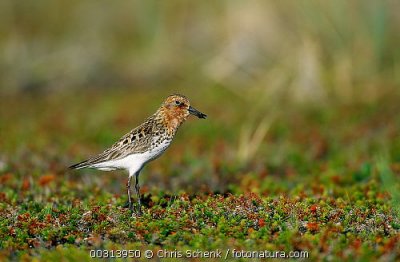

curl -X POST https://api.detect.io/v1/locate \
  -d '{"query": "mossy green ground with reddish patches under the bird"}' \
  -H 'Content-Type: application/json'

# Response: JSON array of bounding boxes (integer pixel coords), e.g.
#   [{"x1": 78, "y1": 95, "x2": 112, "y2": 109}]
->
[{"x1": 0, "y1": 90, "x2": 400, "y2": 261}]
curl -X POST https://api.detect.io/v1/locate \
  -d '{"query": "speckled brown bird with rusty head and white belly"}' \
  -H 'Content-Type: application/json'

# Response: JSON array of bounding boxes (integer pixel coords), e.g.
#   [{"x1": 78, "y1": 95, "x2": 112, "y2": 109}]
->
[{"x1": 69, "y1": 94, "x2": 207, "y2": 215}]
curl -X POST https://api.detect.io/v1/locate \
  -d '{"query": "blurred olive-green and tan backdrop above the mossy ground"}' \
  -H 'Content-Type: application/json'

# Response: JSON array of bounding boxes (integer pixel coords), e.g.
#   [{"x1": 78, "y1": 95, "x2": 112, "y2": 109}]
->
[{"x1": 0, "y1": 0, "x2": 400, "y2": 96}]
